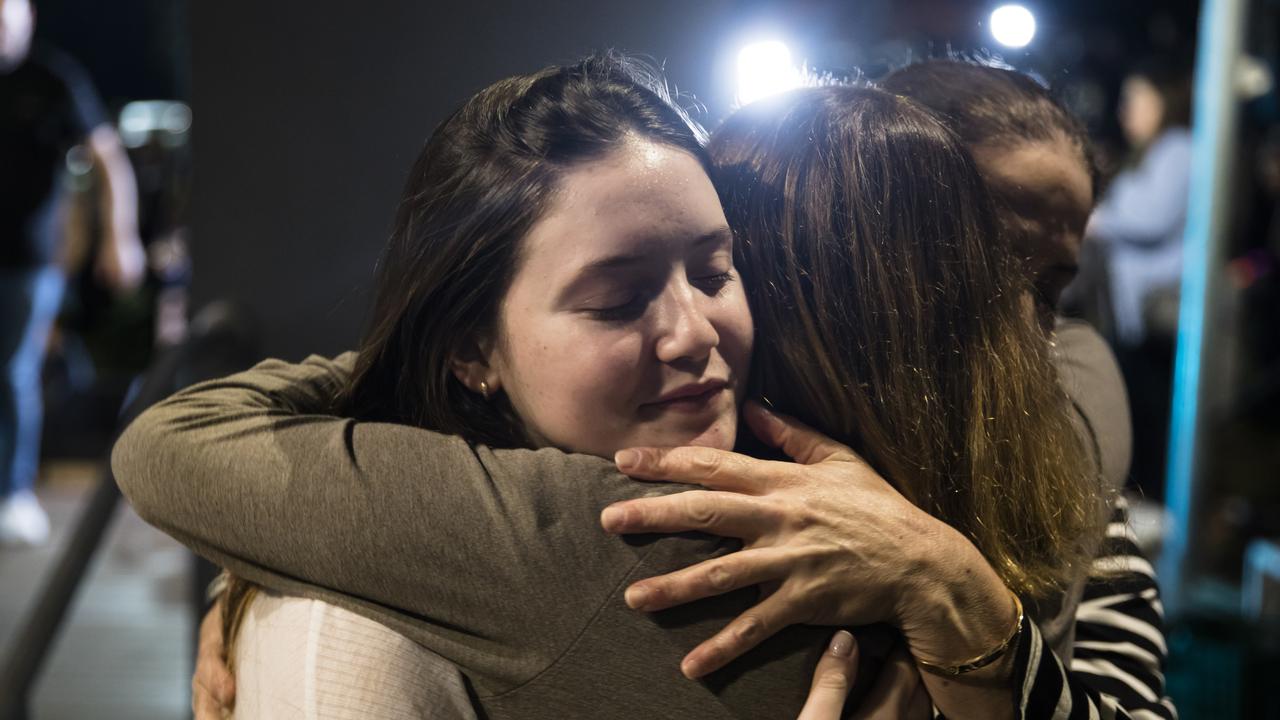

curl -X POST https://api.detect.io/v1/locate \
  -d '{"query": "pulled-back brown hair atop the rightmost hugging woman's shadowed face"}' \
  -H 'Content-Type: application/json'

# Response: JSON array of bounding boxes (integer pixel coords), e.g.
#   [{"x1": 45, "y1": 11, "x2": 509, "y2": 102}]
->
[{"x1": 879, "y1": 59, "x2": 1092, "y2": 161}]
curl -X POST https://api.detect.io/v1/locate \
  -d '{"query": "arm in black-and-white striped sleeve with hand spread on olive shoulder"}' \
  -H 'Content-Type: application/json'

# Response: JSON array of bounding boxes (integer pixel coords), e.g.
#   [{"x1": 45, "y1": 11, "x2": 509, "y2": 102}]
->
[{"x1": 604, "y1": 417, "x2": 1176, "y2": 720}]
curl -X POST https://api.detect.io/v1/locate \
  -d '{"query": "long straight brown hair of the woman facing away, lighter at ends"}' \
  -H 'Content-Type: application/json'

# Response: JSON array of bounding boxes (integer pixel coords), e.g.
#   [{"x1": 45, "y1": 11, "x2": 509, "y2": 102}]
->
[{"x1": 709, "y1": 87, "x2": 1096, "y2": 594}]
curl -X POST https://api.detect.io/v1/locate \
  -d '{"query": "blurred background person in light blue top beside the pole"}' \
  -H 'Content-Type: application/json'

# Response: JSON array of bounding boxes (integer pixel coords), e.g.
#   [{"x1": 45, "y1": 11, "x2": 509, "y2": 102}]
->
[{"x1": 1087, "y1": 60, "x2": 1192, "y2": 501}]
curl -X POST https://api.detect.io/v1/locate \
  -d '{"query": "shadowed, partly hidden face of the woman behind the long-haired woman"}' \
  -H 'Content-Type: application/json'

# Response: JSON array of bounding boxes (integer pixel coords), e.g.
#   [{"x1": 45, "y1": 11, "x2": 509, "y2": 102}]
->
[{"x1": 973, "y1": 135, "x2": 1093, "y2": 329}]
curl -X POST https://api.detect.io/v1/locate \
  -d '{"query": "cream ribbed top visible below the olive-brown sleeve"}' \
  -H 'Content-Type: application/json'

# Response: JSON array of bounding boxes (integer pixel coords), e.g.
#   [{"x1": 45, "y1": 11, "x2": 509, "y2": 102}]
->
[{"x1": 234, "y1": 591, "x2": 476, "y2": 720}]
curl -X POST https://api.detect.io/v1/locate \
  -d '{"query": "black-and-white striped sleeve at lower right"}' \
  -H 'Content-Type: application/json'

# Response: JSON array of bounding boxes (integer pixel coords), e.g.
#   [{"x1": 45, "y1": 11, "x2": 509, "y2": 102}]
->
[{"x1": 1014, "y1": 498, "x2": 1178, "y2": 720}]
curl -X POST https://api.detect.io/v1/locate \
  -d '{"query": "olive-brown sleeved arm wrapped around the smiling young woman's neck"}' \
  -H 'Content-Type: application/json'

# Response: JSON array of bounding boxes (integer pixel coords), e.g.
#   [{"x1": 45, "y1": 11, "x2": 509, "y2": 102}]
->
[{"x1": 113, "y1": 356, "x2": 671, "y2": 691}]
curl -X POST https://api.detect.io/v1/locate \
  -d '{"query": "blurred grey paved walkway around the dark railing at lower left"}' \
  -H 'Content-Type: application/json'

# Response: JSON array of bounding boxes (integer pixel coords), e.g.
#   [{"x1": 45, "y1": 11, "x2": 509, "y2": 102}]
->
[{"x1": 0, "y1": 462, "x2": 192, "y2": 720}]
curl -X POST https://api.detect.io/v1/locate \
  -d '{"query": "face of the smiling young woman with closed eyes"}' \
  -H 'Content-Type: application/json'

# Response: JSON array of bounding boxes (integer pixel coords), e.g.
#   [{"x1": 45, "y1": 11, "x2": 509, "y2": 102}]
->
[{"x1": 473, "y1": 138, "x2": 753, "y2": 456}]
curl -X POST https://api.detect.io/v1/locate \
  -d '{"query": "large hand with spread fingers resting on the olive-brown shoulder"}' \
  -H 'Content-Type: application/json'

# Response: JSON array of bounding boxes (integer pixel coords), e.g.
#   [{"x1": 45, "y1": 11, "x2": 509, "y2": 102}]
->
[{"x1": 602, "y1": 404, "x2": 1014, "y2": 678}]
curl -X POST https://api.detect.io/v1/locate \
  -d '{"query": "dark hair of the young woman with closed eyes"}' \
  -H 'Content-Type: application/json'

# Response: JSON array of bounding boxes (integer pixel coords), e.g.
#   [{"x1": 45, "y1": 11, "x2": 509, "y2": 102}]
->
[{"x1": 346, "y1": 54, "x2": 707, "y2": 446}]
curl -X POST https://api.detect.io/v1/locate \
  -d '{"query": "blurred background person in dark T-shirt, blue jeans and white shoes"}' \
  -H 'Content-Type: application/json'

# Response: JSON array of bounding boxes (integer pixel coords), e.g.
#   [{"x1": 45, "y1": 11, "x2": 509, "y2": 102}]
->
[{"x1": 0, "y1": 0, "x2": 146, "y2": 546}]
